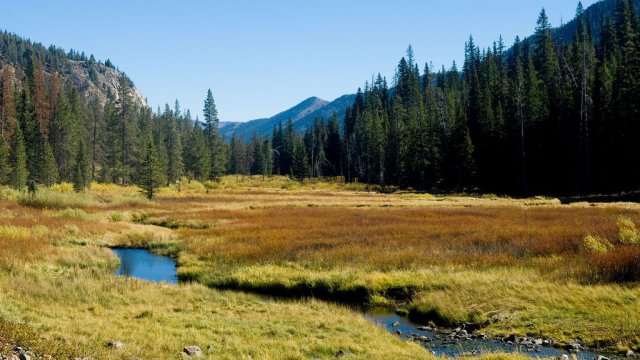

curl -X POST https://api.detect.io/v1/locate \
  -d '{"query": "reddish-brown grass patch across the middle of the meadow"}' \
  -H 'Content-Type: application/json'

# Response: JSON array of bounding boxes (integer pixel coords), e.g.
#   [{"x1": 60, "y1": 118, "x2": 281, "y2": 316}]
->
[{"x1": 157, "y1": 200, "x2": 638, "y2": 275}]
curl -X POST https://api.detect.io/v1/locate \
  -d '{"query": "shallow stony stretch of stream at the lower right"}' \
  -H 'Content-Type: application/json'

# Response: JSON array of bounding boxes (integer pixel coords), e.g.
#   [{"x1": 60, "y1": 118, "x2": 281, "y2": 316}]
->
[{"x1": 365, "y1": 309, "x2": 618, "y2": 360}]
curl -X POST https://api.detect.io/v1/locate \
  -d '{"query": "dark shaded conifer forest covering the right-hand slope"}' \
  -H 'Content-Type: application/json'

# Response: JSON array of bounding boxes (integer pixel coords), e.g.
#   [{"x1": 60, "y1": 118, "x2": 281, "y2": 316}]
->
[{"x1": 233, "y1": 0, "x2": 640, "y2": 195}]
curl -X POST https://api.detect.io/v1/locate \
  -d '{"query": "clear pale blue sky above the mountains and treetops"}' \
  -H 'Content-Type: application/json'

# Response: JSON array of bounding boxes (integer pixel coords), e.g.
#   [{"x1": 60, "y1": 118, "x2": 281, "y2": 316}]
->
[{"x1": 0, "y1": 0, "x2": 597, "y2": 121}]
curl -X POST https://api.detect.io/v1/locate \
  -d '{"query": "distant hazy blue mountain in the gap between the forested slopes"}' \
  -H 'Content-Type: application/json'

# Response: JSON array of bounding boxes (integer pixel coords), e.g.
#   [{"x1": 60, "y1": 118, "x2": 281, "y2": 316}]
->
[{"x1": 220, "y1": 95, "x2": 355, "y2": 140}]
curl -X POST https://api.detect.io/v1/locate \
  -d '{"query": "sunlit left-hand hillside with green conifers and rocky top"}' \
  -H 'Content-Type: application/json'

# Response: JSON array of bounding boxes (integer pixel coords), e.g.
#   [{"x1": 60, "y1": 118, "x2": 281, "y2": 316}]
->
[{"x1": 0, "y1": 32, "x2": 226, "y2": 195}]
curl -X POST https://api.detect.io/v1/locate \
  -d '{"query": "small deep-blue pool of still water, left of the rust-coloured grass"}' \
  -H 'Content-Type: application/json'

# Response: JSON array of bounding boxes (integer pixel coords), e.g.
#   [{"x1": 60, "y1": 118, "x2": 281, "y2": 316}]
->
[{"x1": 113, "y1": 249, "x2": 178, "y2": 284}]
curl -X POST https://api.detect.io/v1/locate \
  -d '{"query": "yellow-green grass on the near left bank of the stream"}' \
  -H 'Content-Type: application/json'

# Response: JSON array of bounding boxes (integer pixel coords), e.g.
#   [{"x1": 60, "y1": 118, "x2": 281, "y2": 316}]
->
[{"x1": 0, "y1": 198, "x2": 429, "y2": 359}]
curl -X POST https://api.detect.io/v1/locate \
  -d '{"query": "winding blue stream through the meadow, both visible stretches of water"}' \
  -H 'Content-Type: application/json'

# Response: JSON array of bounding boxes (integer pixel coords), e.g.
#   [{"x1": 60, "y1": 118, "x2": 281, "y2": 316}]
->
[{"x1": 112, "y1": 248, "x2": 619, "y2": 360}]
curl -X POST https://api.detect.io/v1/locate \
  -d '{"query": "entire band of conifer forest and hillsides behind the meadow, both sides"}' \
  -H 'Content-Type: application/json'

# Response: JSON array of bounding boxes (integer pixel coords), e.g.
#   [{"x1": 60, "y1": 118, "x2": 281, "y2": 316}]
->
[{"x1": 0, "y1": 0, "x2": 640, "y2": 196}]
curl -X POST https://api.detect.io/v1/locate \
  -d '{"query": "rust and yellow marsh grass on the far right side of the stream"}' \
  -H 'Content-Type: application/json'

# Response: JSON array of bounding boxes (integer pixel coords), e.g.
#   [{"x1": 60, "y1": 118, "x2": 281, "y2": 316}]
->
[{"x1": 145, "y1": 189, "x2": 640, "y2": 350}]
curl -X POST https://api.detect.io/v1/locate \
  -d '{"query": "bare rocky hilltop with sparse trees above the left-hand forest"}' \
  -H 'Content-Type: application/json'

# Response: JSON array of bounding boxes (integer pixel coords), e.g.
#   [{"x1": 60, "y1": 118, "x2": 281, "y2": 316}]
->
[{"x1": 0, "y1": 31, "x2": 147, "y2": 107}]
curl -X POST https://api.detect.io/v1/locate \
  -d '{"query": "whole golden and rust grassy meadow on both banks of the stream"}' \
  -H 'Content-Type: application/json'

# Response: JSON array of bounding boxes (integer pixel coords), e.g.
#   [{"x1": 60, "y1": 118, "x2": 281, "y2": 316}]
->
[{"x1": 0, "y1": 176, "x2": 640, "y2": 358}]
